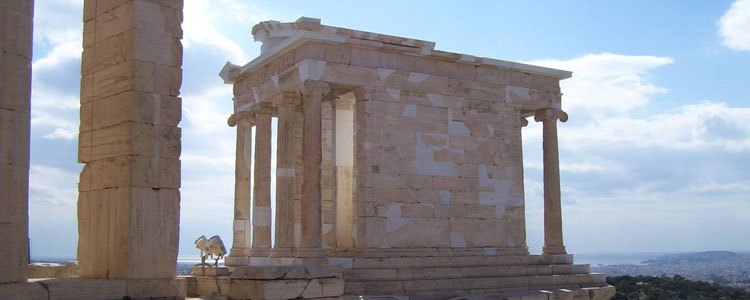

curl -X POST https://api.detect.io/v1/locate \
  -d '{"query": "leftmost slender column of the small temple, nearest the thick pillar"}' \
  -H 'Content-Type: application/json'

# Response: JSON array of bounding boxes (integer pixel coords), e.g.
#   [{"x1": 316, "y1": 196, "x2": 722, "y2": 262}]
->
[{"x1": 225, "y1": 112, "x2": 255, "y2": 266}]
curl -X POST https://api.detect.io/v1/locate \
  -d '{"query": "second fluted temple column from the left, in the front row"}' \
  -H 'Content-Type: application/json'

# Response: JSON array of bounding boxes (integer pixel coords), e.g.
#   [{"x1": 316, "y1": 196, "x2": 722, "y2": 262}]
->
[{"x1": 250, "y1": 109, "x2": 271, "y2": 256}]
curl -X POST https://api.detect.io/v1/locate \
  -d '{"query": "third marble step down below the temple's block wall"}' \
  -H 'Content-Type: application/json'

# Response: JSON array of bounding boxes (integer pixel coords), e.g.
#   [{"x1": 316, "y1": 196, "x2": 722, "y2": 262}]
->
[{"x1": 344, "y1": 273, "x2": 606, "y2": 299}]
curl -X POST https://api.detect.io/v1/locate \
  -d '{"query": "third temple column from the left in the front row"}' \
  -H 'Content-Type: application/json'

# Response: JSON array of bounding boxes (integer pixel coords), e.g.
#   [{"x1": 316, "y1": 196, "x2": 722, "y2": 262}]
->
[{"x1": 271, "y1": 93, "x2": 300, "y2": 257}]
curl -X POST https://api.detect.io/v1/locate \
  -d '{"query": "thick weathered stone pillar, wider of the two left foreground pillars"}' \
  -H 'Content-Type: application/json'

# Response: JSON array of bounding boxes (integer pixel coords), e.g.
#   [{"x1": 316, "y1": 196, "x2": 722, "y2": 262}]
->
[{"x1": 78, "y1": 0, "x2": 183, "y2": 284}]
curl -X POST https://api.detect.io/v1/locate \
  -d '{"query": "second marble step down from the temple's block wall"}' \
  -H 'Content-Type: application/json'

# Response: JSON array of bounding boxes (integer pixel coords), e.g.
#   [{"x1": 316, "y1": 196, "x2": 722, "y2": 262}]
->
[{"x1": 344, "y1": 264, "x2": 590, "y2": 281}]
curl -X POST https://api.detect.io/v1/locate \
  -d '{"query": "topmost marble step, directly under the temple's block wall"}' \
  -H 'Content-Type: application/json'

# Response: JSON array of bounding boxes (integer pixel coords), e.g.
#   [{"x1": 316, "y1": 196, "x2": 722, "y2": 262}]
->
[{"x1": 352, "y1": 255, "x2": 573, "y2": 269}]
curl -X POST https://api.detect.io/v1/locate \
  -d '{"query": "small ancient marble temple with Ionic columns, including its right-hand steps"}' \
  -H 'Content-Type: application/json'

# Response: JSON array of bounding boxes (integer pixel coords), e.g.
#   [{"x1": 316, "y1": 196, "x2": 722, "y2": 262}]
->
[{"x1": 220, "y1": 17, "x2": 614, "y2": 299}]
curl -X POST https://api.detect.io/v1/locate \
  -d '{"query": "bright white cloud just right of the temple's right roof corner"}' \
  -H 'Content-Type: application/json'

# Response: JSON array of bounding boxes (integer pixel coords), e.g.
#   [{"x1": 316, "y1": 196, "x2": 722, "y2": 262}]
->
[{"x1": 528, "y1": 53, "x2": 674, "y2": 116}]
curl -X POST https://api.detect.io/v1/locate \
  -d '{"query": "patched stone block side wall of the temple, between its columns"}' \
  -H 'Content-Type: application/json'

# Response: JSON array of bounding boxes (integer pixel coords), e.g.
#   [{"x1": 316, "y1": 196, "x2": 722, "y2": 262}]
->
[{"x1": 356, "y1": 83, "x2": 526, "y2": 248}]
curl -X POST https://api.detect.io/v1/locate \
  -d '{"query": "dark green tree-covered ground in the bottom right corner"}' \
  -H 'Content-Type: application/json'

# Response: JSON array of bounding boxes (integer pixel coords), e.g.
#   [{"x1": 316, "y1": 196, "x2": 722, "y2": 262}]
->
[{"x1": 607, "y1": 275, "x2": 750, "y2": 300}]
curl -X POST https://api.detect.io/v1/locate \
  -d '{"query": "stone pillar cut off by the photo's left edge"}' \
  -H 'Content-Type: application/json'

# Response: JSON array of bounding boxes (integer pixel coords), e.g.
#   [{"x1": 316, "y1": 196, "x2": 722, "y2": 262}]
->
[{"x1": 0, "y1": 0, "x2": 34, "y2": 284}]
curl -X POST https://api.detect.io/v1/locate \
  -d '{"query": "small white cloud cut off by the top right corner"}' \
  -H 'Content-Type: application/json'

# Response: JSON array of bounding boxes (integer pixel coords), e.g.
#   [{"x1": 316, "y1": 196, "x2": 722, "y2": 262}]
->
[{"x1": 719, "y1": 0, "x2": 750, "y2": 51}]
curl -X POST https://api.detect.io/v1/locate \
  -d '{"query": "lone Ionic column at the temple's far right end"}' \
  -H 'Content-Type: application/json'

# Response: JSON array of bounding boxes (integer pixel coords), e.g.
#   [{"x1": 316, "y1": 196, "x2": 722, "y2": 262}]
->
[{"x1": 534, "y1": 108, "x2": 568, "y2": 254}]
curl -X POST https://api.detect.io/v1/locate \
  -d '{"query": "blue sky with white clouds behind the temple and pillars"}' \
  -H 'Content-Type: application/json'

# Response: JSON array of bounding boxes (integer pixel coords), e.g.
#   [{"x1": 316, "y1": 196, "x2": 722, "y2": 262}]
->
[{"x1": 29, "y1": 0, "x2": 750, "y2": 258}]
